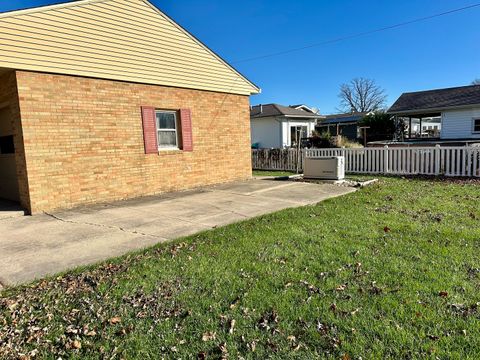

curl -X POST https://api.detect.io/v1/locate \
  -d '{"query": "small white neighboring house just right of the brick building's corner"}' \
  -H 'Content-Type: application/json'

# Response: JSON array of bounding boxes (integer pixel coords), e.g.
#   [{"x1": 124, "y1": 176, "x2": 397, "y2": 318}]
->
[{"x1": 250, "y1": 104, "x2": 324, "y2": 149}]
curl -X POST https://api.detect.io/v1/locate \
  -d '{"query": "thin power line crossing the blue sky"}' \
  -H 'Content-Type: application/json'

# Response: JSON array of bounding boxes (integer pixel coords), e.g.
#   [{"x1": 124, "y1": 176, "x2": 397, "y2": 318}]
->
[{"x1": 232, "y1": 3, "x2": 480, "y2": 64}]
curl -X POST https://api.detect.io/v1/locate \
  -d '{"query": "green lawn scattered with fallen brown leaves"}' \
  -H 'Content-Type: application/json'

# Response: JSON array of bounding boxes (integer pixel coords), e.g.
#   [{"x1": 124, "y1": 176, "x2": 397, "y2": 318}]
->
[{"x1": 0, "y1": 178, "x2": 480, "y2": 359}]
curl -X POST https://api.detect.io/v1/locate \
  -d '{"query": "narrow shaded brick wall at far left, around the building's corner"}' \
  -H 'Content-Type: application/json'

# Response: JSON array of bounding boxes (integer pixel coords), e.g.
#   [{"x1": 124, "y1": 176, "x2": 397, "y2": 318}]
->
[{"x1": 0, "y1": 71, "x2": 30, "y2": 210}]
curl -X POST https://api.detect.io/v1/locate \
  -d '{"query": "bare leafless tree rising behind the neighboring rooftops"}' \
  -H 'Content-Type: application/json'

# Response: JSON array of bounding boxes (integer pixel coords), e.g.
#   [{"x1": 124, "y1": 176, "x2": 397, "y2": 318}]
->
[{"x1": 338, "y1": 78, "x2": 387, "y2": 112}]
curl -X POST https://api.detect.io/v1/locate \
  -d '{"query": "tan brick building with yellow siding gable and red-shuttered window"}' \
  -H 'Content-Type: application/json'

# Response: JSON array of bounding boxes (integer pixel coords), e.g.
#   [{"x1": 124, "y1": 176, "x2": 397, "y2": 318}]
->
[{"x1": 0, "y1": 0, "x2": 260, "y2": 213}]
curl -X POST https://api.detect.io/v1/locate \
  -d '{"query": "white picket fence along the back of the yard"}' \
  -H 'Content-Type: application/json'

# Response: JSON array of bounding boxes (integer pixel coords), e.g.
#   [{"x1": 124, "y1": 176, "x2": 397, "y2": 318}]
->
[{"x1": 252, "y1": 146, "x2": 480, "y2": 177}]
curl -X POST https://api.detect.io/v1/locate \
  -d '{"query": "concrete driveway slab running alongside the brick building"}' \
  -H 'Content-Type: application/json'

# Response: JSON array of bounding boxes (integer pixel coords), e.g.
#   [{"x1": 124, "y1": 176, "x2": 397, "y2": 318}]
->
[{"x1": 0, "y1": 179, "x2": 354, "y2": 286}]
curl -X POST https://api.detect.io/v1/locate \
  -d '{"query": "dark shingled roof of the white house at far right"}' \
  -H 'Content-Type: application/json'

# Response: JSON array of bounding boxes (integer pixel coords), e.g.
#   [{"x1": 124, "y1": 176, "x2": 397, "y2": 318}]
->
[{"x1": 388, "y1": 85, "x2": 480, "y2": 114}]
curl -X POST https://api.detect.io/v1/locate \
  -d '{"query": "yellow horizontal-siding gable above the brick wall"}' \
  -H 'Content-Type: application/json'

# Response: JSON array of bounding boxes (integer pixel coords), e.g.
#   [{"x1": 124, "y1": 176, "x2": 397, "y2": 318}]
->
[{"x1": 0, "y1": 0, "x2": 260, "y2": 95}]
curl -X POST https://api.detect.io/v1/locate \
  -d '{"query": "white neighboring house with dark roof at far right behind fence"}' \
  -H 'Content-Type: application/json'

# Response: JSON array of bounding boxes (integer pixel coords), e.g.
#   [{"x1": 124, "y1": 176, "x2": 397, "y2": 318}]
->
[{"x1": 388, "y1": 85, "x2": 480, "y2": 142}]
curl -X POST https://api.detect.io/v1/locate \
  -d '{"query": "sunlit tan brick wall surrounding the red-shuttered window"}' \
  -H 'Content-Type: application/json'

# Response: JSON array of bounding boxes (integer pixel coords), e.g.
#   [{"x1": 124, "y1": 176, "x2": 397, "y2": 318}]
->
[{"x1": 17, "y1": 72, "x2": 251, "y2": 213}]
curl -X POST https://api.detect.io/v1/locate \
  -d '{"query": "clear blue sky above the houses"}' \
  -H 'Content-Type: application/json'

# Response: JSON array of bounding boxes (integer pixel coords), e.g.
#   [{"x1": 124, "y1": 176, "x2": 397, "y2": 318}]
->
[{"x1": 0, "y1": 0, "x2": 480, "y2": 114}]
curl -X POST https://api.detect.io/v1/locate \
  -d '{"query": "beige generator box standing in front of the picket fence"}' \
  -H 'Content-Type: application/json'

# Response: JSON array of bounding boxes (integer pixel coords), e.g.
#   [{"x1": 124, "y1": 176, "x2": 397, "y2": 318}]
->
[{"x1": 304, "y1": 156, "x2": 345, "y2": 180}]
